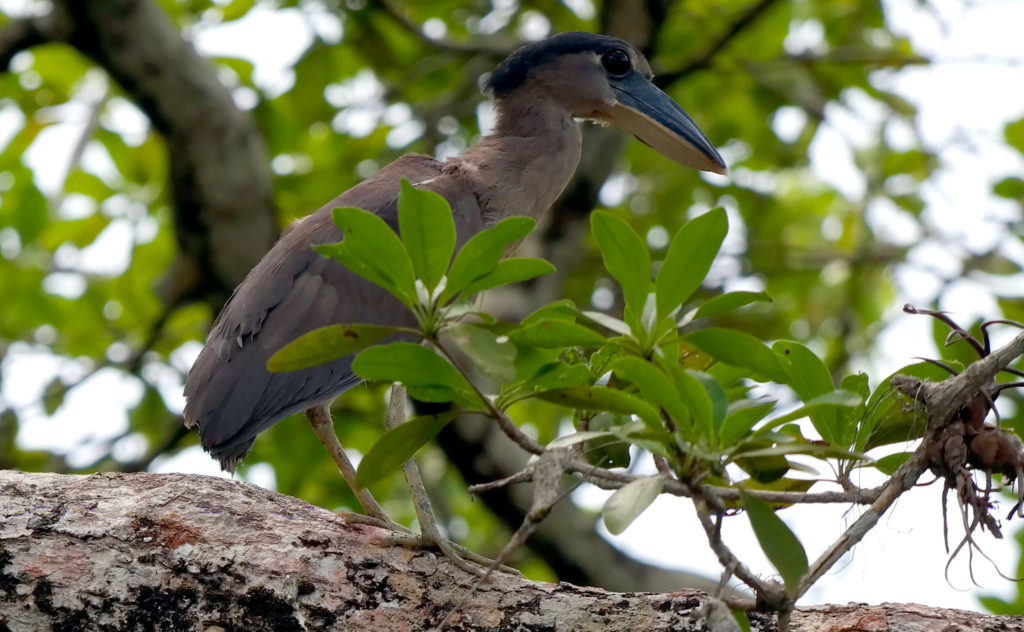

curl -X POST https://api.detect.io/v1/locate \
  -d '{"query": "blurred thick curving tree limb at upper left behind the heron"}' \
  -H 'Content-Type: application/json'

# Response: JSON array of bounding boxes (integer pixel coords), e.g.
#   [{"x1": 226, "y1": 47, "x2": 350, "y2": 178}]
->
[{"x1": 0, "y1": 0, "x2": 278, "y2": 305}]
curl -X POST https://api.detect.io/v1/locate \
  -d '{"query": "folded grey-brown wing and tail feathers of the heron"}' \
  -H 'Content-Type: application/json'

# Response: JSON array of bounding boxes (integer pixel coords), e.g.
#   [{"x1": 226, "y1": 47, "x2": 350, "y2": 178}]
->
[{"x1": 184, "y1": 156, "x2": 480, "y2": 469}]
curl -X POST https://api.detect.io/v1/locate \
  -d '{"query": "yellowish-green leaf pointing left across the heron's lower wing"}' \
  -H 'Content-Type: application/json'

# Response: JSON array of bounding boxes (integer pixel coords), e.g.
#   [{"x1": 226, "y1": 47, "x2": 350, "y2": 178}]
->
[{"x1": 266, "y1": 325, "x2": 399, "y2": 373}]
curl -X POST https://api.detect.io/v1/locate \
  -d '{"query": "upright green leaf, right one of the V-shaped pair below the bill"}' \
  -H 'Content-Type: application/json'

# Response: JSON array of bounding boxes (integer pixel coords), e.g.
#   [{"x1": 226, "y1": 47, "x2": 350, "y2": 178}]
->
[{"x1": 655, "y1": 208, "x2": 729, "y2": 319}]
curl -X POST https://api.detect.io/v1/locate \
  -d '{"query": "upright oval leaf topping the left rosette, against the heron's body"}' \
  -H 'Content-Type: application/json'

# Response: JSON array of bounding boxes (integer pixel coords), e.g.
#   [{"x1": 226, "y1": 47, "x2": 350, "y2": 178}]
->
[{"x1": 398, "y1": 178, "x2": 455, "y2": 292}]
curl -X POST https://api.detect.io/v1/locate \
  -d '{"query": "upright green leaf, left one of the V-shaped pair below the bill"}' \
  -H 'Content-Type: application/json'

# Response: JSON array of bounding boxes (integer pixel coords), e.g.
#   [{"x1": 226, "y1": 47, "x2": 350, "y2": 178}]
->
[{"x1": 590, "y1": 211, "x2": 653, "y2": 314}]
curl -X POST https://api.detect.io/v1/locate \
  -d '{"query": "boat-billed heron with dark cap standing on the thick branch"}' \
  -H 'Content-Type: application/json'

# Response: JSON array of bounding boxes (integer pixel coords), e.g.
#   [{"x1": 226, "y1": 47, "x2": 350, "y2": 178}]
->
[{"x1": 184, "y1": 33, "x2": 725, "y2": 532}]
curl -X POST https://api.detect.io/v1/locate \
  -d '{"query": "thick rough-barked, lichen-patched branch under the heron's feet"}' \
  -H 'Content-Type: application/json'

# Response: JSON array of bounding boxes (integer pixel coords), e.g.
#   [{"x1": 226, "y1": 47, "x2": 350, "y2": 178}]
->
[{"x1": 0, "y1": 471, "x2": 1024, "y2": 632}]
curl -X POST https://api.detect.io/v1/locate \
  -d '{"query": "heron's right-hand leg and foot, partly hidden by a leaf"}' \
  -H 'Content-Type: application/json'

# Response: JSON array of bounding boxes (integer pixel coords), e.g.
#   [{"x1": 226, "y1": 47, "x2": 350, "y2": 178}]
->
[{"x1": 386, "y1": 384, "x2": 518, "y2": 577}]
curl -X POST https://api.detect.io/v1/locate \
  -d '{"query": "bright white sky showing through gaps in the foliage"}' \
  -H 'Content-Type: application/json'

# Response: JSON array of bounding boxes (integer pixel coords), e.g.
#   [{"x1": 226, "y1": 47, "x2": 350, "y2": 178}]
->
[{"x1": 0, "y1": 0, "x2": 1024, "y2": 609}]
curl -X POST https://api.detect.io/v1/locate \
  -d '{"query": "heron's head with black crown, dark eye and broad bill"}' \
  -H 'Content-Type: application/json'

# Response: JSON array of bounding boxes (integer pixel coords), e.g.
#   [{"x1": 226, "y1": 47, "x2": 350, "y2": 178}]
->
[{"x1": 487, "y1": 33, "x2": 726, "y2": 174}]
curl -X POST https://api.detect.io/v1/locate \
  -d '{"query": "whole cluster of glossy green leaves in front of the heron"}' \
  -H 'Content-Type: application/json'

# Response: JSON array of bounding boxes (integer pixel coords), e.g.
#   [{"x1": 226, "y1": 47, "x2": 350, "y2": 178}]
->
[{"x1": 268, "y1": 181, "x2": 962, "y2": 593}]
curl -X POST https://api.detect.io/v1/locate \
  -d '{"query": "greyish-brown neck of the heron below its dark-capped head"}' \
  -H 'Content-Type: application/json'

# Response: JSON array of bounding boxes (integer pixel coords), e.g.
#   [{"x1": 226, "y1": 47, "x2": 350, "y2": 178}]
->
[{"x1": 451, "y1": 94, "x2": 582, "y2": 226}]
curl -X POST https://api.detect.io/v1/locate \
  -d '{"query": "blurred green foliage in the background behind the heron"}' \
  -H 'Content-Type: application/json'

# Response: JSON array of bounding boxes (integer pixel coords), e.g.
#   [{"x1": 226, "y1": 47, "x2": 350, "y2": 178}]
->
[{"x1": 0, "y1": 0, "x2": 1024, "y2": 612}]
